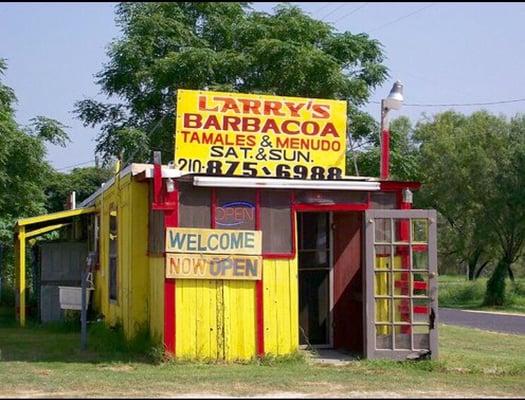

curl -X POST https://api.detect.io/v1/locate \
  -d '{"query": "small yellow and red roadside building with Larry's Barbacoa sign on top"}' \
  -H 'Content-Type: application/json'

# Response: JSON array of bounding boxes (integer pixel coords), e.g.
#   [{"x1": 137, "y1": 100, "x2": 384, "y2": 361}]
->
[{"x1": 16, "y1": 90, "x2": 437, "y2": 360}]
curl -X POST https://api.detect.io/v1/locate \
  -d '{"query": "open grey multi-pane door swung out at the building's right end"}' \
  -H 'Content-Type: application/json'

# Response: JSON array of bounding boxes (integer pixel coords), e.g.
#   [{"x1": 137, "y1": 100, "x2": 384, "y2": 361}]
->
[{"x1": 364, "y1": 210, "x2": 438, "y2": 359}]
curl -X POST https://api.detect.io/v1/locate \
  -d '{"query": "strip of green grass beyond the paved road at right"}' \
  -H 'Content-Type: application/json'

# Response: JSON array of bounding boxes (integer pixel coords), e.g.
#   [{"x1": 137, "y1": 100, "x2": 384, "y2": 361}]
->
[{"x1": 439, "y1": 275, "x2": 525, "y2": 313}]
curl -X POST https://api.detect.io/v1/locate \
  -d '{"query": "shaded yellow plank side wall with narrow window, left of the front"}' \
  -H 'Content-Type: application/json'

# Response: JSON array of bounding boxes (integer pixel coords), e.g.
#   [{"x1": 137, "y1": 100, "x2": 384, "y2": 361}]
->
[{"x1": 95, "y1": 175, "x2": 150, "y2": 337}]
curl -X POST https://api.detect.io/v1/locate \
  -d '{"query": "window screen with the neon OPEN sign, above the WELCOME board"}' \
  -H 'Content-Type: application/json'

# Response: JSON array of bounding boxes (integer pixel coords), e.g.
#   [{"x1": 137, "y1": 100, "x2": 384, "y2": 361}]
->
[{"x1": 215, "y1": 188, "x2": 254, "y2": 230}]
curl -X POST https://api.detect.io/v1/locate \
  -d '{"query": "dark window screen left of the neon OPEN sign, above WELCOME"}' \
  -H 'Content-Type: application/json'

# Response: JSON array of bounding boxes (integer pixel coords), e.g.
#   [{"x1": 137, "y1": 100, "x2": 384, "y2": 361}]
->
[{"x1": 179, "y1": 182, "x2": 211, "y2": 228}]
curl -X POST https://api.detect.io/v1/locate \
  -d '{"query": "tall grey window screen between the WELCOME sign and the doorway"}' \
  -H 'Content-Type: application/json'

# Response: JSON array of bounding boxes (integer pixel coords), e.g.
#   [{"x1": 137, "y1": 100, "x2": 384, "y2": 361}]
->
[{"x1": 260, "y1": 190, "x2": 293, "y2": 254}]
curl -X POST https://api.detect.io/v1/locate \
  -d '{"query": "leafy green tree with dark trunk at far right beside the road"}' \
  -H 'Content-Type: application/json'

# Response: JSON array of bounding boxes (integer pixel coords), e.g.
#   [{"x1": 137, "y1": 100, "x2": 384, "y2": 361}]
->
[{"x1": 414, "y1": 111, "x2": 525, "y2": 305}]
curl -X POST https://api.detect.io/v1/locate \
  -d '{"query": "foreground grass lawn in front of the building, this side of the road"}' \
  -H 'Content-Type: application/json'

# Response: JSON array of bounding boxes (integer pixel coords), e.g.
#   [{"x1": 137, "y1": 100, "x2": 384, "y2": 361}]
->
[{"x1": 0, "y1": 313, "x2": 525, "y2": 397}]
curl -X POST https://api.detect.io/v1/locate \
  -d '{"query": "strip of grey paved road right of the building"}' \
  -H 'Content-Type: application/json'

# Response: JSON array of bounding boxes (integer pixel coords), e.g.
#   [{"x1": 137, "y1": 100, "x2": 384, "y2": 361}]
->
[{"x1": 439, "y1": 308, "x2": 525, "y2": 335}]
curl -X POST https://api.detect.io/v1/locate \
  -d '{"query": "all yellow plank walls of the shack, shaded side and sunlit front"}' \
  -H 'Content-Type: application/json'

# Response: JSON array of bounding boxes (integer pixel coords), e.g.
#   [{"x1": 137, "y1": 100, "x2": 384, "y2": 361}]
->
[{"x1": 94, "y1": 176, "x2": 299, "y2": 360}]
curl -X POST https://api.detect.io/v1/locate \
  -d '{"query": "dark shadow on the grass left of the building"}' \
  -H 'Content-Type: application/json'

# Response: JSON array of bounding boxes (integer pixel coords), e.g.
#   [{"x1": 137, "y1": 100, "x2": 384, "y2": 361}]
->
[{"x1": 0, "y1": 308, "x2": 163, "y2": 364}]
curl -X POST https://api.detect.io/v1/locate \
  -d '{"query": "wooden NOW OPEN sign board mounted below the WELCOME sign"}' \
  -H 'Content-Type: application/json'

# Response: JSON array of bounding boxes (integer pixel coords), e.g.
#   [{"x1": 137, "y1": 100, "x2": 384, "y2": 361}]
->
[{"x1": 166, "y1": 253, "x2": 262, "y2": 280}]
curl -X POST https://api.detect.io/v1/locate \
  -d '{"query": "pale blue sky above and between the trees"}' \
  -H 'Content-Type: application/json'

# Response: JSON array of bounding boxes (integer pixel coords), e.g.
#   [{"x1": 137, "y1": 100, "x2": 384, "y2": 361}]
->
[{"x1": 0, "y1": 2, "x2": 525, "y2": 171}]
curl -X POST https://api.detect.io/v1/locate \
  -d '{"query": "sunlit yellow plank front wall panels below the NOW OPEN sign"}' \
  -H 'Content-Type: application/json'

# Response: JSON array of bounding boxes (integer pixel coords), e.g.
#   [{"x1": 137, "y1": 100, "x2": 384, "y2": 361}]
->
[{"x1": 175, "y1": 260, "x2": 299, "y2": 360}]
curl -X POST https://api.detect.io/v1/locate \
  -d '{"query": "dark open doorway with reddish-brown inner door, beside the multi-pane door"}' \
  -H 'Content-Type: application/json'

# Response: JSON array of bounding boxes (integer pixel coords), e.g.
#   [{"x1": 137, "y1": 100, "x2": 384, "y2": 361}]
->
[{"x1": 297, "y1": 212, "x2": 364, "y2": 354}]
